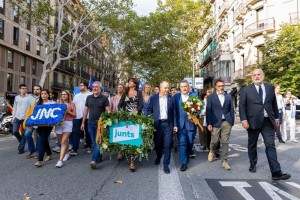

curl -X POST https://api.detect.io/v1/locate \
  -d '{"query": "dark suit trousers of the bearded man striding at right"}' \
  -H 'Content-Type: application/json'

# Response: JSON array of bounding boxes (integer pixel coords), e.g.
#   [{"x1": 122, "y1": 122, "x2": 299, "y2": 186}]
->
[{"x1": 248, "y1": 117, "x2": 281, "y2": 173}]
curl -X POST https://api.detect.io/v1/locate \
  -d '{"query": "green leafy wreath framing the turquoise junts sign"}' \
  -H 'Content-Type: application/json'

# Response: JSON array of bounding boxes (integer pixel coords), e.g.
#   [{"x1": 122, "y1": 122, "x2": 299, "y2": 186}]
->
[{"x1": 99, "y1": 110, "x2": 154, "y2": 158}]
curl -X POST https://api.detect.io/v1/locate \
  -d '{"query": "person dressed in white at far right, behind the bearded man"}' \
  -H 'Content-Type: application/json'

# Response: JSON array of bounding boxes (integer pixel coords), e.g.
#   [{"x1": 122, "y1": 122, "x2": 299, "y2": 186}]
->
[{"x1": 282, "y1": 91, "x2": 298, "y2": 142}]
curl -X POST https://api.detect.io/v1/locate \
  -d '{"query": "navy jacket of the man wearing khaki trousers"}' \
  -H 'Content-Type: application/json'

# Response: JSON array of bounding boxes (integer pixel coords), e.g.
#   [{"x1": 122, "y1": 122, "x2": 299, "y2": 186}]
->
[{"x1": 206, "y1": 92, "x2": 234, "y2": 127}]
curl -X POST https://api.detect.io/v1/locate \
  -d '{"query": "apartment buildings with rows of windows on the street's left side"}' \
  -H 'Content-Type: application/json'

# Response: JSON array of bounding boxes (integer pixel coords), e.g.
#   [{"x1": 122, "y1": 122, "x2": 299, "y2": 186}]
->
[{"x1": 0, "y1": 0, "x2": 116, "y2": 96}]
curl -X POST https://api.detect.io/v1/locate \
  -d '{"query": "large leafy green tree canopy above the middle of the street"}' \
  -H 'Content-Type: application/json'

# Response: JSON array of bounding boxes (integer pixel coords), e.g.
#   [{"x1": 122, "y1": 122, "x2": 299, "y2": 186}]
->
[{"x1": 124, "y1": 0, "x2": 213, "y2": 85}]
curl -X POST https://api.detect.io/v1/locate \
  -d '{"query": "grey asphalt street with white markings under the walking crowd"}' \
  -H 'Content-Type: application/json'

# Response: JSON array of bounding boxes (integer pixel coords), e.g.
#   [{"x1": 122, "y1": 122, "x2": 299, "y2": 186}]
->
[{"x1": 0, "y1": 121, "x2": 300, "y2": 200}]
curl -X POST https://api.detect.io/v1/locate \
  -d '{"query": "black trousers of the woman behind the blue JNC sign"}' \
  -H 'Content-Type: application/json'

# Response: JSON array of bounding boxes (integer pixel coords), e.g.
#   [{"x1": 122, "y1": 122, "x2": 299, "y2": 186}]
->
[{"x1": 37, "y1": 126, "x2": 53, "y2": 161}]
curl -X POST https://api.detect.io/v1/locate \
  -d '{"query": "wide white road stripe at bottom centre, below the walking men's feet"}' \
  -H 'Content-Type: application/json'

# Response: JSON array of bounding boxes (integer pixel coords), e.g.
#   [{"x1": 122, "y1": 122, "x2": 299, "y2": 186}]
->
[{"x1": 158, "y1": 156, "x2": 185, "y2": 200}]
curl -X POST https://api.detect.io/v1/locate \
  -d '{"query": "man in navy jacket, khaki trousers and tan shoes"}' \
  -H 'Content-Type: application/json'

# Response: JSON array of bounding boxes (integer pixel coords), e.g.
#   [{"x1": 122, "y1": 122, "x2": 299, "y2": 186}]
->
[{"x1": 206, "y1": 79, "x2": 234, "y2": 170}]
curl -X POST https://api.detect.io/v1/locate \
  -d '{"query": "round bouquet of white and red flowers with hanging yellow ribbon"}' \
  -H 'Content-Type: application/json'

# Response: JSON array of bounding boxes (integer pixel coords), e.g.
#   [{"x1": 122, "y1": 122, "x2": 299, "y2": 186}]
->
[{"x1": 181, "y1": 96, "x2": 204, "y2": 130}]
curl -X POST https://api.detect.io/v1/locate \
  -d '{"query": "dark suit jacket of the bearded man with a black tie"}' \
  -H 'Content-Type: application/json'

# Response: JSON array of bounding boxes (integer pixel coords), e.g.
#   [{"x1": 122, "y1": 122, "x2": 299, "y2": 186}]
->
[{"x1": 239, "y1": 83, "x2": 279, "y2": 129}]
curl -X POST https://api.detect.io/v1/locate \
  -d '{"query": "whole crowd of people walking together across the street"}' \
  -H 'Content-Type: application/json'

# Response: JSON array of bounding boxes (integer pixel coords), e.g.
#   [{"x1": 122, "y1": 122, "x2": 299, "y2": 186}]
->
[{"x1": 13, "y1": 69, "x2": 298, "y2": 180}]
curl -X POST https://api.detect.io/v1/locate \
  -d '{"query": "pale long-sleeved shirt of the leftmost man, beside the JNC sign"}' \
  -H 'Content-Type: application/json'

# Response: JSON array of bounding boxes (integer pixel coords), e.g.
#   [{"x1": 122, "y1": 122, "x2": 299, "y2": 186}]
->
[{"x1": 13, "y1": 94, "x2": 36, "y2": 120}]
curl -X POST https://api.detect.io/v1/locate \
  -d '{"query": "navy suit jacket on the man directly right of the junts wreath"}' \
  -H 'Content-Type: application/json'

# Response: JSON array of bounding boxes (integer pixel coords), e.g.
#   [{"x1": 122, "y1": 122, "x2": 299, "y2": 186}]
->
[{"x1": 147, "y1": 94, "x2": 174, "y2": 129}]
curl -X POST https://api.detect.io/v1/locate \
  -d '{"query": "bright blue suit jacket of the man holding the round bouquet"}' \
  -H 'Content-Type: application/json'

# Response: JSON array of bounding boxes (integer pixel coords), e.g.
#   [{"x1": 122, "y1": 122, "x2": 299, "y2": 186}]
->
[{"x1": 173, "y1": 93, "x2": 197, "y2": 131}]
